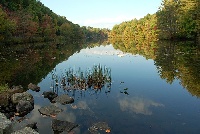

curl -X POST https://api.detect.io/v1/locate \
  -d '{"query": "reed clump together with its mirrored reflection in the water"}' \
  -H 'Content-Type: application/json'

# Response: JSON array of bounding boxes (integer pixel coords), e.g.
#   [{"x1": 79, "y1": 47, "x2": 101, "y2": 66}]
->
[{"x1": 50, "y1": 64, "x2": 112, "y2": 98}]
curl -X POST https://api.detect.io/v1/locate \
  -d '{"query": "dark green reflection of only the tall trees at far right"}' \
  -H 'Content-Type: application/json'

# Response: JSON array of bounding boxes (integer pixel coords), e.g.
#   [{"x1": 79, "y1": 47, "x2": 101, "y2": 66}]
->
[{"x1": 155, "y1": 42, "x2": 200, "y2": 97}]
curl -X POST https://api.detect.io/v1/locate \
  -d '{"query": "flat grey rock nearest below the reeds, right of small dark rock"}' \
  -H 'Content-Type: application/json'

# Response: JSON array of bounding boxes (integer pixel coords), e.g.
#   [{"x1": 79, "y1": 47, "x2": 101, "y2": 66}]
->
[{"x1": 52, "y1": 94, "x2": 74, "y2": 105}]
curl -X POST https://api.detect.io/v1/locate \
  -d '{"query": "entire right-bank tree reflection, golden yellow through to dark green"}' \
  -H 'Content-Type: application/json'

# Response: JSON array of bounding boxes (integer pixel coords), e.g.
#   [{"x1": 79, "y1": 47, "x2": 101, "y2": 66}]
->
[{"x1": 110, "y1": 38, "x2": 200, "y2": 96}]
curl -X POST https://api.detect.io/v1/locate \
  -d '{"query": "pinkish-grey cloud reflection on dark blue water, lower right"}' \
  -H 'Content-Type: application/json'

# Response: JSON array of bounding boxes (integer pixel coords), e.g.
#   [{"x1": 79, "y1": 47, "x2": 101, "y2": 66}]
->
[{"x1": 119, "y1": 97, "x2": 164, "y2": 115}]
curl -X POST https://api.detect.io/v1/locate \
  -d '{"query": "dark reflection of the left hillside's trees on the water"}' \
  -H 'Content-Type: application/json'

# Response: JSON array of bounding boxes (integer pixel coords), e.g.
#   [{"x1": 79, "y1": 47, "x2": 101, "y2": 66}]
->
[{"x1": 0, "y1": 43, "x2": 80, "y2": 87}]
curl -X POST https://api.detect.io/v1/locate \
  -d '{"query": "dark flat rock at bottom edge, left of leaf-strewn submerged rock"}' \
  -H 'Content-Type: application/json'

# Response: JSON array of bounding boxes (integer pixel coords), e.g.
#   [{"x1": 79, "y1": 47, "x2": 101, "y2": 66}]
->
[{"x1": 52, "y1": 119, "x2": 78, "y2": 132}]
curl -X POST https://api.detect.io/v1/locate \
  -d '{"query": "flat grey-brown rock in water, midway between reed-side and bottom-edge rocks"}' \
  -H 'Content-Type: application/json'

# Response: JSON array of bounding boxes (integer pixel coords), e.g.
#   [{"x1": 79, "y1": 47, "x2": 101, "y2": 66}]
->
[{"x1": 38, "y1": 105, "x2": 63, "y2": 117}]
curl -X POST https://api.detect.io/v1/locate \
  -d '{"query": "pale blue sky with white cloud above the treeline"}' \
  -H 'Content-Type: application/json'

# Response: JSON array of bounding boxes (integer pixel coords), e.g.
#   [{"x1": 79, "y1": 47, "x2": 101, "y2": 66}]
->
[{"x1": 40, "y1": 0, "x2": 162, "y2": 29}]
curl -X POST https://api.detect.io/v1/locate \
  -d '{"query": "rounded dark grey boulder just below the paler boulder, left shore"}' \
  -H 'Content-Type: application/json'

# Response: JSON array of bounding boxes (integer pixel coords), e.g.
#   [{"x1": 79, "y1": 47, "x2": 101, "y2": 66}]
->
[{"x1": 16, "y1": 100, "x2": 34, "y2": 116}]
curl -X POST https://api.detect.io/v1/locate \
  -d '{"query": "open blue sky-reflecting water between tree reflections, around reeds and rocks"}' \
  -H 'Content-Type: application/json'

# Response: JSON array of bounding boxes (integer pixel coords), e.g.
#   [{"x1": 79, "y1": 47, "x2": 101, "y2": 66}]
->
[{"x1": 26, "y1": 45, "x2": 200, "y2": 134}]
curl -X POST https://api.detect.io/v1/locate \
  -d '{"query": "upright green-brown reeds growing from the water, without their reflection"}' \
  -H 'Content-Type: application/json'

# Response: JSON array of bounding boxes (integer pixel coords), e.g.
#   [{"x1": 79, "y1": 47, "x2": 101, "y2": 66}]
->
[{"x1": 52, "y1": 64, "x2": 111, "y2": 90}]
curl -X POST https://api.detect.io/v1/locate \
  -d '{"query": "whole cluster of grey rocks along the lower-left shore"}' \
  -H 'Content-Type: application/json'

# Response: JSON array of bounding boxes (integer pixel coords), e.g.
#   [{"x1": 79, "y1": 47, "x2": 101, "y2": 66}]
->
[{"x1": 0, "y1": 83, "x2": 78, "y2": 134}]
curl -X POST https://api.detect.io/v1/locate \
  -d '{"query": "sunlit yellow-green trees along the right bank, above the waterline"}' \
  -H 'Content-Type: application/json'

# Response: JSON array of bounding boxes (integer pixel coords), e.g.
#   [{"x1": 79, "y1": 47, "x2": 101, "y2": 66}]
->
[{"x1": 109, "y1": 0, "x2": 200, "y2": 41}]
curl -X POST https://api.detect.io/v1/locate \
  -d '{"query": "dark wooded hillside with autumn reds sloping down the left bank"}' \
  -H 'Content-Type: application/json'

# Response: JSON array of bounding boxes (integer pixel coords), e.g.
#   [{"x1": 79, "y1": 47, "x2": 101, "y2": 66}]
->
[{"x1": 0, "y1": 0, "x2": 109, "y2": 43}]
